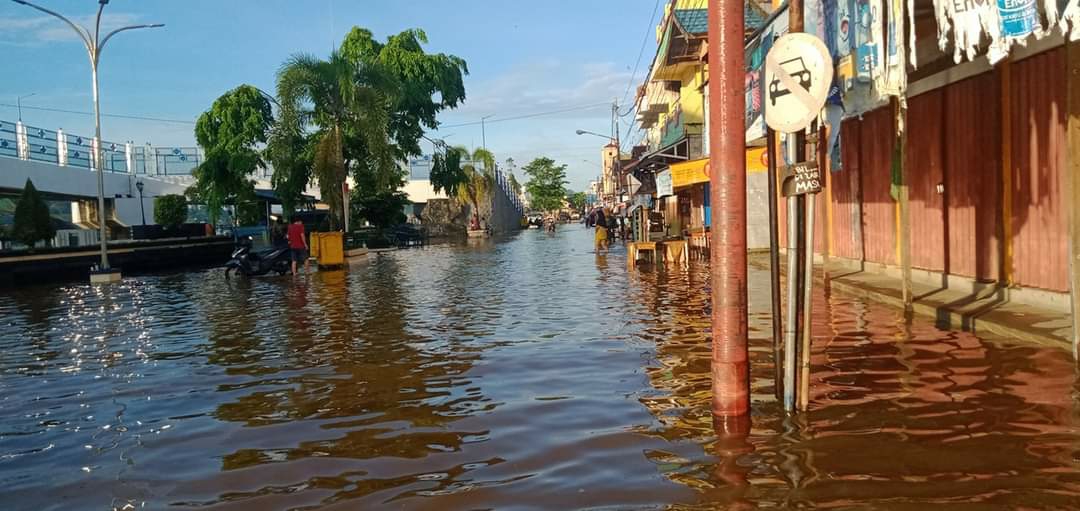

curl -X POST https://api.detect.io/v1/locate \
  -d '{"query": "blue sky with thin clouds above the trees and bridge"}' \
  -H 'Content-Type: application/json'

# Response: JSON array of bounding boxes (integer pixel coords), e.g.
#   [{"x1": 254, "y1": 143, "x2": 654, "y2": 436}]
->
[{"x1": 0, "y1": 0, "x2": 657, "y2": 190}]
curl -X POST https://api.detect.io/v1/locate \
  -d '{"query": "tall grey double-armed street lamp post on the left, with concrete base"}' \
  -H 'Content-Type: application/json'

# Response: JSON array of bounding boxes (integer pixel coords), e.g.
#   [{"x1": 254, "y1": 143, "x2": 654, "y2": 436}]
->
[{"x1": 12, "y1": 0, "x2": 165, "y2": 282}]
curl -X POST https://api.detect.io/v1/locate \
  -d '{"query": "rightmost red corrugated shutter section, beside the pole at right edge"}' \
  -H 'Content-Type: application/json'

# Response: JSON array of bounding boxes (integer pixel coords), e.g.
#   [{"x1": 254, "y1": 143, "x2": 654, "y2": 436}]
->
[{"x1": 1011, "y1": 48, "x2": 1069, "y2": 292}]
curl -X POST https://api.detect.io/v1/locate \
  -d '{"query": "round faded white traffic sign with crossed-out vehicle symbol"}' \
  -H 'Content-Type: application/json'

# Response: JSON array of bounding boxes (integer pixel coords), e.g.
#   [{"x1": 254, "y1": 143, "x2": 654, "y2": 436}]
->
[{"x1": 764, "y1": 32, "x2": 833, "y2": 133}]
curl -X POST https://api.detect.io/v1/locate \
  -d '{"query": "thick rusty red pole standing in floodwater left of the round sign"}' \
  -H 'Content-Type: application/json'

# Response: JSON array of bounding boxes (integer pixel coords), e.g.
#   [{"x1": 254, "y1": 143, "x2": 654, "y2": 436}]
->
[{"x1": 708, "y1": 0, "x2": 750, "y2": 425}]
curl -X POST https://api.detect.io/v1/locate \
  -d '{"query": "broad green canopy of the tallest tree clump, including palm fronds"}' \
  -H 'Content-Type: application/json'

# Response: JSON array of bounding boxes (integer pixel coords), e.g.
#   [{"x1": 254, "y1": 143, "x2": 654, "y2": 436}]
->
[{"x1": 268, "y1": 27, "x2": 468, "y2": 229}]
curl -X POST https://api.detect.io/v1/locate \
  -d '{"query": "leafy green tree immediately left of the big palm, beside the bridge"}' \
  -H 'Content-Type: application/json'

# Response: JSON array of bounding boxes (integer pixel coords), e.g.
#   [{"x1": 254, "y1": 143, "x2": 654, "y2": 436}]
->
[{"x1": 187, "y1": 85, "x2": 273, "y2": 224}]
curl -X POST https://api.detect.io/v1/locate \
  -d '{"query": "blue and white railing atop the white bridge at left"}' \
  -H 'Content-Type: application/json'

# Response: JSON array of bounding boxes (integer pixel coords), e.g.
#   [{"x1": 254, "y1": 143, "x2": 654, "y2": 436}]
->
[{"x1": 0, "y1": 120, "x2": 202, "y2": 175}]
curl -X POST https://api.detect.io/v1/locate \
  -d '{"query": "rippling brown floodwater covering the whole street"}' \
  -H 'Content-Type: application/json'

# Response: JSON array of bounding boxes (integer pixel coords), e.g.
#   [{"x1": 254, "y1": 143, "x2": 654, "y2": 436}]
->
[{"x1": 0, "y1": 226, "x2": 1080, "y2": 511}]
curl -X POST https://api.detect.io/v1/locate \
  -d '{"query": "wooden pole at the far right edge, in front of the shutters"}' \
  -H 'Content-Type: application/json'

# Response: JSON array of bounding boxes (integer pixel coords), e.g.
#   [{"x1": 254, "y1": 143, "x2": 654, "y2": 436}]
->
[{"x1": 1064, "y1": 41, "x2": 1080, "y2": 360}]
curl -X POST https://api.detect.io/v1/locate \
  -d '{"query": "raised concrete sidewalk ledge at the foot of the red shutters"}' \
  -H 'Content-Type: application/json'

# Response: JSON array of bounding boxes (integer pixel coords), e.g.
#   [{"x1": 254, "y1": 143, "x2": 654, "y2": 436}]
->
[{"x1": 750, "y1": 252, "x2": 1072, "y2": 350}]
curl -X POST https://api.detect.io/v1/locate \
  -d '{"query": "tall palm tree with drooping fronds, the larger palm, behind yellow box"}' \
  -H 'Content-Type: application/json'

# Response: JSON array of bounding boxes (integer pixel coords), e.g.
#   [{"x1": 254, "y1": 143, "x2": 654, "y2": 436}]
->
[{"x1": 278, "y1": 51, "x2": 394, "y2": 228}]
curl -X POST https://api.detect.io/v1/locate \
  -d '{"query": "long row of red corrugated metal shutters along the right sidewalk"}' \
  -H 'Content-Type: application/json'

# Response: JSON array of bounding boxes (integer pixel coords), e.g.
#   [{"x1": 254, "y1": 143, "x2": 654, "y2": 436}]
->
[{"x1": 807, "y1": 48, "x2": 1068, "y2": 293}]
